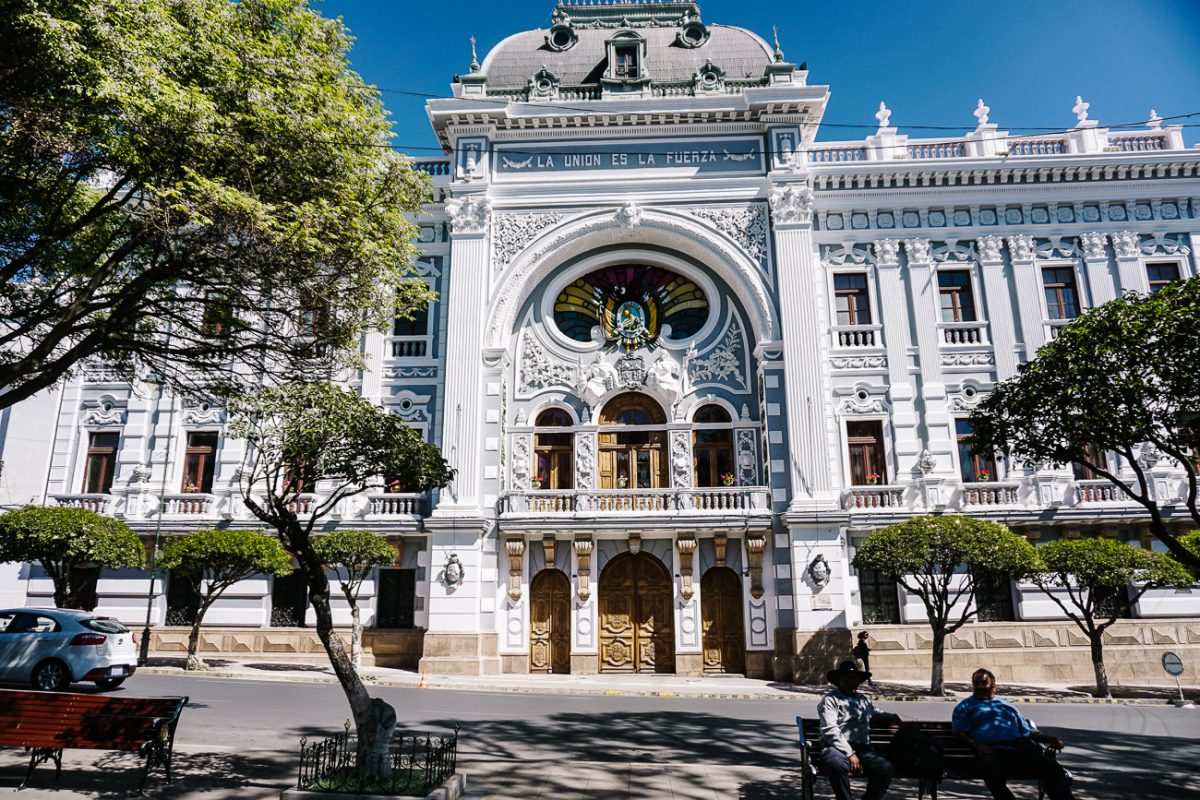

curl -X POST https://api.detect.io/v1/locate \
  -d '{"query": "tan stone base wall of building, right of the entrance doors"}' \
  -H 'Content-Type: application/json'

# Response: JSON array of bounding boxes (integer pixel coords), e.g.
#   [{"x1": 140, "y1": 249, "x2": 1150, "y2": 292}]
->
[{"x1": 775, "y1": 619, "x2": 1200, "y2": 687}]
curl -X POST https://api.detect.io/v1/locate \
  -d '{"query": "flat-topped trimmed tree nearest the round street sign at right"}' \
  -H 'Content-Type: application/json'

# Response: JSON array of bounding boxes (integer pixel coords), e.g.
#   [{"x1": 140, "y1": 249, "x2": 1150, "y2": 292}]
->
[{"x1": 1026, "y1": 536, "x2": 1192, "y2": 697}]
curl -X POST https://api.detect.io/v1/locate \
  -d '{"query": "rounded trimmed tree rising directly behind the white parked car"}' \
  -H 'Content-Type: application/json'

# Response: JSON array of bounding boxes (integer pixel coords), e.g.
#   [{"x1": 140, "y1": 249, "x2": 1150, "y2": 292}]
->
[{"x1": 0, "y1": 506, "x2": 146, "y2": 608}]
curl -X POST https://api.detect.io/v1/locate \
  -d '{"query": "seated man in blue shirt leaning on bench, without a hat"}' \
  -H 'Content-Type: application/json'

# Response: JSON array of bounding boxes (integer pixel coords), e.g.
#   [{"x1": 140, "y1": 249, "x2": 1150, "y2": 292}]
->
[{"x1": 950, "y1": 669, "x2": 1074, "y2": 800}]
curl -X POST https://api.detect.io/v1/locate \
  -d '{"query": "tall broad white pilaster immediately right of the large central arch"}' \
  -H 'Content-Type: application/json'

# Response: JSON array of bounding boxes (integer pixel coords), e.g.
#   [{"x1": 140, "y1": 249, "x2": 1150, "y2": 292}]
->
[{"x1": 770, "y1": 181, "x2": 840, "y2": 509}]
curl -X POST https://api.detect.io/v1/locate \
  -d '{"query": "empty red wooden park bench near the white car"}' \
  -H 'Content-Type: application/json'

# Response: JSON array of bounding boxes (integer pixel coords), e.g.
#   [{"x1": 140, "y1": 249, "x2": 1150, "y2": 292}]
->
[{"x1": 0, "y1": 690, "x2": 187, "y2": 794}]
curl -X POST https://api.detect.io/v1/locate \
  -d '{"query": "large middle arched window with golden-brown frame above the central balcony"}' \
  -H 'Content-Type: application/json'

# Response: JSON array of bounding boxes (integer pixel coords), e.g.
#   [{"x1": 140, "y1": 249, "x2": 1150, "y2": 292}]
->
[{"x1": 600, "y1": 393, "x2": 667, "y2": 489}]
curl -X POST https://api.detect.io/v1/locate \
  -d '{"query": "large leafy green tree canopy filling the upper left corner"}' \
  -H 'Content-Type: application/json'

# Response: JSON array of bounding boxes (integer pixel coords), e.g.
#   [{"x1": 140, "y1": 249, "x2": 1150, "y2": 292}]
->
[{"x1": 0, "y1": 0, "x2": 432, "y2": 408}]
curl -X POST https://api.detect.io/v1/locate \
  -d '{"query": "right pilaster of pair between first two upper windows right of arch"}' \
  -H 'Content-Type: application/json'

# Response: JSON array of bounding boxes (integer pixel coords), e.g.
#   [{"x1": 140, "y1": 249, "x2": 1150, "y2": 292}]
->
[{"x1": 904, "y1": 239, "x2": 954, "y2": 473}]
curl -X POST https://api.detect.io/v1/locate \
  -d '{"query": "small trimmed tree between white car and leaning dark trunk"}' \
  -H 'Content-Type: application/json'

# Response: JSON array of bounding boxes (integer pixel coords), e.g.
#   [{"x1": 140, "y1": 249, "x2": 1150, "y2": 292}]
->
[{"x1": 158, "y1": 529, "x2": 292, "y2": 669}]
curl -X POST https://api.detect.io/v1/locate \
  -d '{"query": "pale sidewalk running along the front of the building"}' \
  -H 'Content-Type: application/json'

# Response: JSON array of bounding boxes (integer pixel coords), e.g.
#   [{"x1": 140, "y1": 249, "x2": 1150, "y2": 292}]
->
[{"x1": 139, "y1": 657, "x2": 1200, "y2": 705}]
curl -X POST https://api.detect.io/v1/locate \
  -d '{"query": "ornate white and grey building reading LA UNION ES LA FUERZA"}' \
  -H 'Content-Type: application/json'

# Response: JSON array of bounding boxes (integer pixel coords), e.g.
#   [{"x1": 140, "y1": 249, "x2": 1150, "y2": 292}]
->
[{"x1": 0, "y1": 2, "x2": 1200, "y2": 681}]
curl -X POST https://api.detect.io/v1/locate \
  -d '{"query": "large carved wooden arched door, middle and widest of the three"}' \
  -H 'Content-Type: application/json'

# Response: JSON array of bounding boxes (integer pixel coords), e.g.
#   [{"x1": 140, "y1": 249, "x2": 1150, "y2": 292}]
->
[{"x1": 600, "y1": 553, "x2": 674, "y2": 673}]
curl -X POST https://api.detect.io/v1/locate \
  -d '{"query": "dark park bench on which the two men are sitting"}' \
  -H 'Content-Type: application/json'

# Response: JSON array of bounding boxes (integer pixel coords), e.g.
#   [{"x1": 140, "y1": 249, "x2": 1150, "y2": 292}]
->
[{"x1": 796, "y1": 717, "x2": 1055, "y2": 800}]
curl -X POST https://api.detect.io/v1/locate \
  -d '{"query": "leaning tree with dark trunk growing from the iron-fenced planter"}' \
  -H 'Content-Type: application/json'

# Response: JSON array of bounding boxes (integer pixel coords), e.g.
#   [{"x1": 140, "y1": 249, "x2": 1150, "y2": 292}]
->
[{"x1": 229, "y1": 383, "x2": 452, "y2": 782}]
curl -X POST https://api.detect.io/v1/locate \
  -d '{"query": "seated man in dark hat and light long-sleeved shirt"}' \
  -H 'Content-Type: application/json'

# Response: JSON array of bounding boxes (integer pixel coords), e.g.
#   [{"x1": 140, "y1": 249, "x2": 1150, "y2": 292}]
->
[{"x1": 817, "y1": 660, "x2": 900, "y2": 800}]
